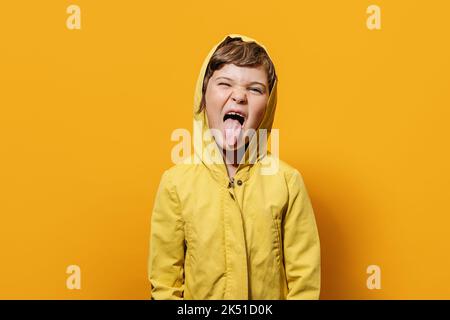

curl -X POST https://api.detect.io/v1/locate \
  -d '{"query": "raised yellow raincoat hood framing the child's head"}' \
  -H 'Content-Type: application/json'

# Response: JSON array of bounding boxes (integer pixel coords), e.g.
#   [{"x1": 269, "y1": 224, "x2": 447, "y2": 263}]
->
[{"x1": 193, "y1": 34, "x2": 278, "y2": 182}]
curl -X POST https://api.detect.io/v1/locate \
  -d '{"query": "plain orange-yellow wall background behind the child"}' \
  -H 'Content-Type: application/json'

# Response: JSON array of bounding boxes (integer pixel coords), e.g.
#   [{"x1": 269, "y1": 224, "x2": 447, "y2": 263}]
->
[{"x1": 0, "y1": 0, "x2": 450, "y2": 299}]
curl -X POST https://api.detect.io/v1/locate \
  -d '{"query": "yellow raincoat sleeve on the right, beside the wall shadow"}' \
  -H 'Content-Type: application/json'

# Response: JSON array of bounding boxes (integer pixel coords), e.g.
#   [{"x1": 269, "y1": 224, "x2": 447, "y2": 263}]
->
[{"x1": 283, "y1": 170, "x2": 320, "y2": 300}]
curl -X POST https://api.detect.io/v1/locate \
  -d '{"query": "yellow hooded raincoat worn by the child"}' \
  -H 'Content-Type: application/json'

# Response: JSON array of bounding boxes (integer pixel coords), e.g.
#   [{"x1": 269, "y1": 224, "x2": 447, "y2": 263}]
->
[{"x1": 148, "y1": 34, "x2": 320, "y2": 300}]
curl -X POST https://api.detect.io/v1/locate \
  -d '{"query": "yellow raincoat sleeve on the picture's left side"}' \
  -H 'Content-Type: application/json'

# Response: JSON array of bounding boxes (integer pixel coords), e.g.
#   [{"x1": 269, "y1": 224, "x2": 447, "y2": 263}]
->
[{"x1": 148, "y1": 171, "x2": 185, "y2": 300}]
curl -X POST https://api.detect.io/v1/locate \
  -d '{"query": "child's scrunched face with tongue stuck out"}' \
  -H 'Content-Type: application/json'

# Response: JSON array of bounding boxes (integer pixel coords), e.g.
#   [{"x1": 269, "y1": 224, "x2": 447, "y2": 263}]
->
[{"x1": 205, "y1": 64, "x2": 269, "y2": 150}]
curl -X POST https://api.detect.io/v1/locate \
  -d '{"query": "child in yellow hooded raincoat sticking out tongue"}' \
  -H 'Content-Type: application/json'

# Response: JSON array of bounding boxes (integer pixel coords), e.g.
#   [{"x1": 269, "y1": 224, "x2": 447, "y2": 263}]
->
[{"x1": 148, "y1": 35, "x2": 320, "y2": 300}]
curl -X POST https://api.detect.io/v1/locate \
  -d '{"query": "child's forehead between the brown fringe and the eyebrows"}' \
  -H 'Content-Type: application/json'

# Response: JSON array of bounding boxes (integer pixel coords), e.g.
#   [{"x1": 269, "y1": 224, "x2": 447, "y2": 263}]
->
[{"x1": 212, "y1": 64, "x2": 267, "y2": 84}]
